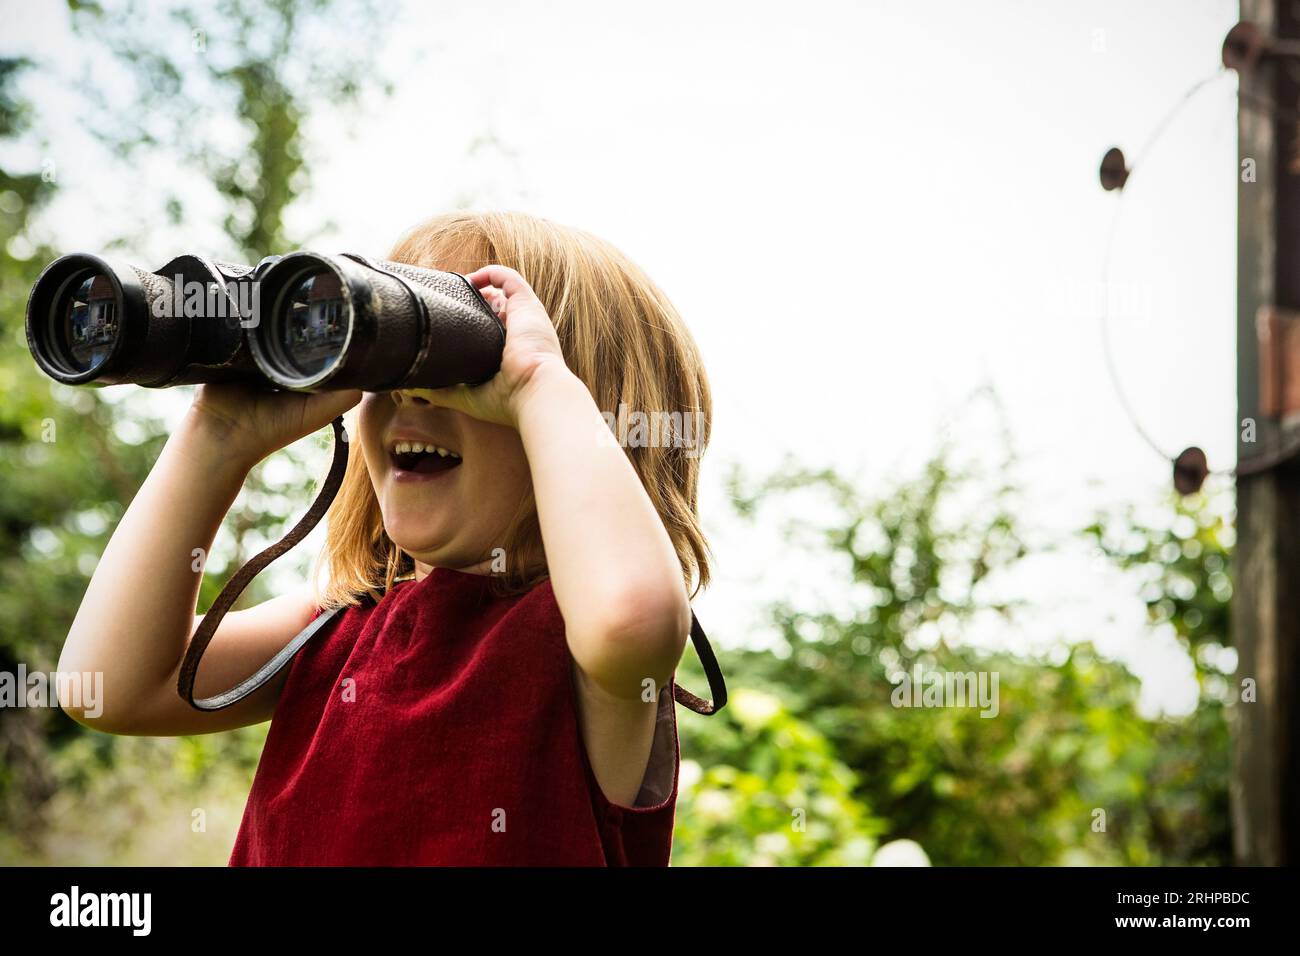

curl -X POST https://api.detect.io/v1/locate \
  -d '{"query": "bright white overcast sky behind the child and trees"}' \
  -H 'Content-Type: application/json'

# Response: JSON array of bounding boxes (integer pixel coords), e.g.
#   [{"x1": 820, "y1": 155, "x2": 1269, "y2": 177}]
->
[{"x1": 0, "y1": 0, "x2": 1238, "y2": 708}]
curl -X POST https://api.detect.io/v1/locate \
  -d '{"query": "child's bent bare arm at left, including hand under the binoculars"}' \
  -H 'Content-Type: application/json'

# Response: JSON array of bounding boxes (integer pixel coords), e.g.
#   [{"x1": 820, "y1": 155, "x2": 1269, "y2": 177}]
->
[{"x1": 59, "y1": 385, "x2": 360, "y2": 735}]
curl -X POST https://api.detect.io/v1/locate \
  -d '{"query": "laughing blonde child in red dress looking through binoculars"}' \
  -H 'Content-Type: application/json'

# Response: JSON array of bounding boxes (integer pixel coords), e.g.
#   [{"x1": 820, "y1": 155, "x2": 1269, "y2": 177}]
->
[{"x1": 59, "y1": 212, "x2": 711, "y2": 865}]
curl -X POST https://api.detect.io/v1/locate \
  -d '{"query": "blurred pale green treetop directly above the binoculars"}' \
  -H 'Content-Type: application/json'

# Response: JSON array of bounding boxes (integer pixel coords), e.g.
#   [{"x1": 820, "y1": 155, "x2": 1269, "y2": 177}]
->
[{"x1": 73, "y1": 0, "x2": 394, "y2": 261}]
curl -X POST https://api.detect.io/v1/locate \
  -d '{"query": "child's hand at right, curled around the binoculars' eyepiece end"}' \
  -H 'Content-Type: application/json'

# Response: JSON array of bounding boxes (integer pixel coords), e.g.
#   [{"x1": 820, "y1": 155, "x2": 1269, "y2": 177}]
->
[{"x1": 403, "y1": 265, "x2": 568, "y2": 428}]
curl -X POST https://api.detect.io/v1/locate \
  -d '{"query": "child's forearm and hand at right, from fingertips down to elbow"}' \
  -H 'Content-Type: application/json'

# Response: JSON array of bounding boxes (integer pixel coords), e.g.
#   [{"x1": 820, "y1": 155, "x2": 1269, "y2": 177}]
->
[{"x1": 421, "y1": 265, "x2": 690, "y2": 702}]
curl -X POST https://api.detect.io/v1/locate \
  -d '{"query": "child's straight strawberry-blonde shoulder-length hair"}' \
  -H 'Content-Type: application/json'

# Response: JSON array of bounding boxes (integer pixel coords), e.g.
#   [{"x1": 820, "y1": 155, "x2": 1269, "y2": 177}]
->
[{"x1": 315, "y1": 212, "x2": 712, "y2": 607}]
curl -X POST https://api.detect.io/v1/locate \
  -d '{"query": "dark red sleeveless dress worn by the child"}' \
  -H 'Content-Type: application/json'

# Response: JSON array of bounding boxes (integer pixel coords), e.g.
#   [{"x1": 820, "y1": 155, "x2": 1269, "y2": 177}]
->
[{"x1": 230, "y1": 568, "x2": 681, "y2": 866}]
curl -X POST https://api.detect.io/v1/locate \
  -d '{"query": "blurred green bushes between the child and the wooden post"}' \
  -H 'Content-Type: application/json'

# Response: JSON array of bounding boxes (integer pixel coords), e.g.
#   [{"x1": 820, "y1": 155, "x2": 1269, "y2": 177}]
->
[{"x1": 675, "y1": 451, "x2": 1231, "y2": 865}]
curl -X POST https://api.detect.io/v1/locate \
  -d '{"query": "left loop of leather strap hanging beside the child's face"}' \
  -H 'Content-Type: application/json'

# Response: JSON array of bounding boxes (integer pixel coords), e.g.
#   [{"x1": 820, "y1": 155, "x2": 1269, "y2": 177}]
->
[{"x1": 176, "y1": 415, "x2": 347, "y2": 710}]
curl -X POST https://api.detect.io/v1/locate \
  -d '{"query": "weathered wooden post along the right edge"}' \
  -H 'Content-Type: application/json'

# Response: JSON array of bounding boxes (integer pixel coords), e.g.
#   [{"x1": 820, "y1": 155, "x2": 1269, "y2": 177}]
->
[{"x1": 1232, "y1": 0, "x2": 1300, "y2": 865}]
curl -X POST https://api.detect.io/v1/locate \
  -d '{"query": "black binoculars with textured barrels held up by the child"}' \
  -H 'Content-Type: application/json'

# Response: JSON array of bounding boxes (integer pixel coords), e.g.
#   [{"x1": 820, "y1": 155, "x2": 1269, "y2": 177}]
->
[{"x1": 27, "y1": 251, "x2": 506, "y2": 392}]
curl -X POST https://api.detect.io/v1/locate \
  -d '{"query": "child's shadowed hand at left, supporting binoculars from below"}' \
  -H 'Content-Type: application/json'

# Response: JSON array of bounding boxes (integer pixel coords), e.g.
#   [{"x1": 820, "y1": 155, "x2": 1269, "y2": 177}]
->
[{"x1": 190, "y1": 382, "x2": 361, "y2": 468}]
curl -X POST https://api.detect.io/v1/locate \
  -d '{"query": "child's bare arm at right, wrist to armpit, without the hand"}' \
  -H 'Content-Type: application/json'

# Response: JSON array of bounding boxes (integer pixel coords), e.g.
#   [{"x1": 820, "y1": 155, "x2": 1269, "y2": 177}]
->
[{"x1": 519, "y1": 360, "x2": 690, "y2": 806}]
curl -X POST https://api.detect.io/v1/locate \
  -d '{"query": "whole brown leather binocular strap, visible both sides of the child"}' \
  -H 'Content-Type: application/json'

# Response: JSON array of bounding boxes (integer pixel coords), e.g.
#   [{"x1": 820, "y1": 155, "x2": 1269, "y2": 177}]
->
[{"x1": 176, "y1": 415, "x2": 727, "y2": 717}]
